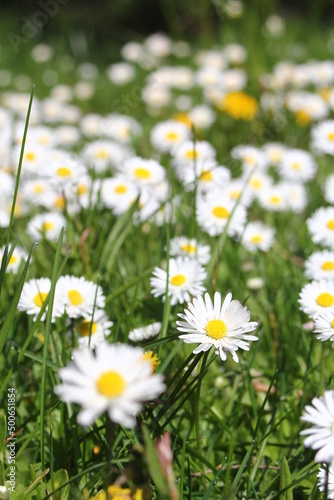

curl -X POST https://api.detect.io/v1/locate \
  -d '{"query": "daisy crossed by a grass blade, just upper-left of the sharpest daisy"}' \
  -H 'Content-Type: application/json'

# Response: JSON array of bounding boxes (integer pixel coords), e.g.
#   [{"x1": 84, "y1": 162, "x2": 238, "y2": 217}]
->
[{"x1": 150, "y1": 257, "x2": 206, "y2": 306}]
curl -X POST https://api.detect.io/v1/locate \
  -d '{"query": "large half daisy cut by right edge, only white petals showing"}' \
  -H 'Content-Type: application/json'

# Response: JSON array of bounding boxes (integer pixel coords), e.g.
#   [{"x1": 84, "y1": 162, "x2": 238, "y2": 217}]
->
[{"x1": 300, "y1": 391, "x2": 334, "y2": 464}]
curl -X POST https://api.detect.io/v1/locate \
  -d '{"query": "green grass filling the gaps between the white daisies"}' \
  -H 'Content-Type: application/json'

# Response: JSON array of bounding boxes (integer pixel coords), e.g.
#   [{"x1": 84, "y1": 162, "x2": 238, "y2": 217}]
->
[{"x1": 0, "y1": 3, "x2": 333, "y2": 500}]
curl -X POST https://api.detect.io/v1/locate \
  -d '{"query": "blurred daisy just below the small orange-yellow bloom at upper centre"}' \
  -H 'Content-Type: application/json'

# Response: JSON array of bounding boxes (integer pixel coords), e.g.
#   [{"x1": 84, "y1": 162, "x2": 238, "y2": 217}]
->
[{"x1": 151, "y1": 120, "x2": 191, "y2": 153}]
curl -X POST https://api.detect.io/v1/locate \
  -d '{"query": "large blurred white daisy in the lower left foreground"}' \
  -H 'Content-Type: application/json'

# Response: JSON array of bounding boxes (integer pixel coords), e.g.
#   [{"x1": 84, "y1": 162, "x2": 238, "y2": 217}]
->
[{"x1": 55, "y1": 343, "x2": 165, "y2": 428}]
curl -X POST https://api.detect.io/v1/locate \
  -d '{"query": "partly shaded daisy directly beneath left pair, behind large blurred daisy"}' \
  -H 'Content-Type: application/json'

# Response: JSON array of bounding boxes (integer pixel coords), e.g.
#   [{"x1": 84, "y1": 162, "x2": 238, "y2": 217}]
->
[{"x1": 76, "y1": 309, "x2": 114, "y2": 349}]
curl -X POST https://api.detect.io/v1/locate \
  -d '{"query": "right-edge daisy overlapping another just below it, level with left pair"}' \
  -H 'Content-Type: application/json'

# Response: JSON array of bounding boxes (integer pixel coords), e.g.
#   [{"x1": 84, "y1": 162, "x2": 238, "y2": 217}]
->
[{"x1": 298, "y1": 279, "x2": 334, "y2": 318}]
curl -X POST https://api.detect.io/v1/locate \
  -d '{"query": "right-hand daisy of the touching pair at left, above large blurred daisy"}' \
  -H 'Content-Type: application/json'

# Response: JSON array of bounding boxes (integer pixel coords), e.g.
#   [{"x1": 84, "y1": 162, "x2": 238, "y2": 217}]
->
[{"x1": 56, "y1": 275, "x2": 105, "y2": 318}]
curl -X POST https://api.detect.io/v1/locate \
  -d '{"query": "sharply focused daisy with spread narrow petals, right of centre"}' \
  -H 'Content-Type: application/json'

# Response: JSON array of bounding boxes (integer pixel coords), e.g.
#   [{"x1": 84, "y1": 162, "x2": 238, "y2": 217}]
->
[{"x1": 176, "y1": 292, "x2": 258, "y2": 363}]
